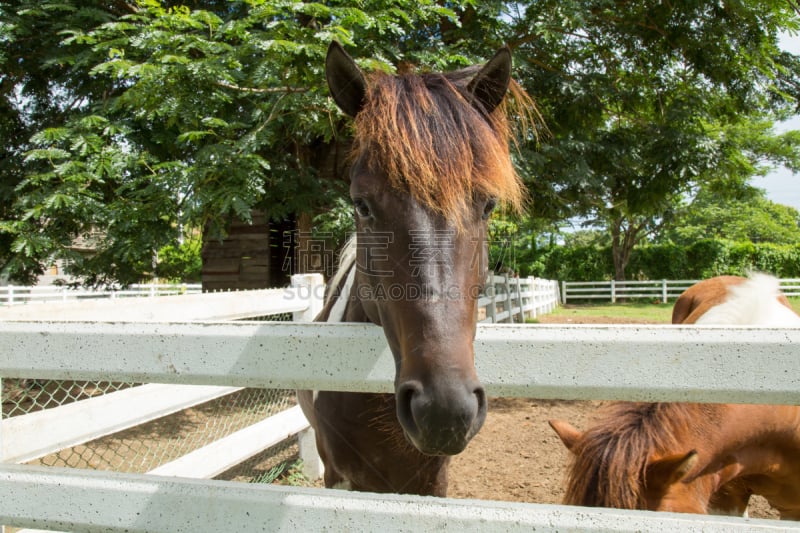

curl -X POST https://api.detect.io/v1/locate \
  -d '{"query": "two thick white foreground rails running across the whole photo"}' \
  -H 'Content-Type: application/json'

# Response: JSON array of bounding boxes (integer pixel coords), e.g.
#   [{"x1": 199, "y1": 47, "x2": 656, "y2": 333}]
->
[{"x1": 0, "y1": 322, "x2": 800, "y2": 533}]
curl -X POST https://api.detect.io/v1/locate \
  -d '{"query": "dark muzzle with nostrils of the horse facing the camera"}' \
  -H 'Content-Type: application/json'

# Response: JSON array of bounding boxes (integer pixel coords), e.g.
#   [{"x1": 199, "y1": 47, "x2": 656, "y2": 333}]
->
[{"x1": 396, "y1": 380, "x2": 487, "y2": 455}]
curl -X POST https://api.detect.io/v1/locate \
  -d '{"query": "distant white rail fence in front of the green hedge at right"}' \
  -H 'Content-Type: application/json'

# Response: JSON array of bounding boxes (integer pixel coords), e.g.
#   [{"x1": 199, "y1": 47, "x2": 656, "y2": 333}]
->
[{"x1": 561, "y1": 279, "x2": 800, "y2": 304}]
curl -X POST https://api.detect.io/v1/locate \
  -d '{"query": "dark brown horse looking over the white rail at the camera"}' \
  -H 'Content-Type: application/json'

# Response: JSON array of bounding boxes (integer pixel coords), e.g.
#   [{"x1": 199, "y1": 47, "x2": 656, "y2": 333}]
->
[{"x1": 300, "y1": 43, "x2": 526, "y2": 496}]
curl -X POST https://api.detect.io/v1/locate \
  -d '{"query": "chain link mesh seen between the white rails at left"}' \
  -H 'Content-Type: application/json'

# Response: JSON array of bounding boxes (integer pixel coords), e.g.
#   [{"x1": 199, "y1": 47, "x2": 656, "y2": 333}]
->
[{"x1": 0, "y1": 313, "x2": 310, "y2": 490}]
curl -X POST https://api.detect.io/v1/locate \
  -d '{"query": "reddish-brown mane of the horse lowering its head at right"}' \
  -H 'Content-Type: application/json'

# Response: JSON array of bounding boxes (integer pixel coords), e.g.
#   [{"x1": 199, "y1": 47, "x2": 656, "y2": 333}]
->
[{"x1": 564, "y1": 402, "x2": 716, "y2": 509}]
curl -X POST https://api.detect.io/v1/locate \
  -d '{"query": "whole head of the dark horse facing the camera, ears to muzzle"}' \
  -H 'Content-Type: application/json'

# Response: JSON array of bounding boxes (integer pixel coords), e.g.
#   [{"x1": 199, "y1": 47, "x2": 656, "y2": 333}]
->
[{"x1": 326, "y1": 43, "x2": 522, "y2": 455}]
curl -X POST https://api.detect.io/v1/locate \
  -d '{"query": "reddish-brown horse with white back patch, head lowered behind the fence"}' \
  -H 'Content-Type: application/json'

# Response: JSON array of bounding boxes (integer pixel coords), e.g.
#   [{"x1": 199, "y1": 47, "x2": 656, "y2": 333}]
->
[{"x1": 550, "y1": 275, "x2": 800, "y2": 520}]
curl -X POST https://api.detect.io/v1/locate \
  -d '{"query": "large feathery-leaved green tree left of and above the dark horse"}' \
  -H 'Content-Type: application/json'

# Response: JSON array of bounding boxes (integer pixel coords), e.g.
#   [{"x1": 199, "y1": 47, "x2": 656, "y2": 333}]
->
[{"x1": 0, "y1": 0, "x2": 502, "y2": 284}]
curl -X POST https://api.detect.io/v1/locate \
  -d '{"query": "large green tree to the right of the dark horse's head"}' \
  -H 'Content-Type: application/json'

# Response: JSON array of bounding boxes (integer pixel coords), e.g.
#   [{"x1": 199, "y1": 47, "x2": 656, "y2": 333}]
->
[{"x1": 510, "y1": 0, "x2": 800, "y2": 280}]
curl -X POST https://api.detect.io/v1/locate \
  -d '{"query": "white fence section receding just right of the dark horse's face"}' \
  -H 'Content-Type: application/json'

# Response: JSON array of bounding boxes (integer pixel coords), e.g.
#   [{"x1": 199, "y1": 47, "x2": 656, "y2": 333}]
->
[{"x1": 478, "y1": 274, "x2": 559, "y2": 324}]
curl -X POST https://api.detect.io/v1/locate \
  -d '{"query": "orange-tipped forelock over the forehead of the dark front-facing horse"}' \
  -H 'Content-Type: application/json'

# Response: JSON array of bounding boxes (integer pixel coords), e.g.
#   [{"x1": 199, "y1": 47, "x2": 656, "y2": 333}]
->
[{"x1": 353, "y1": 67, "x2": 538, "y2": 227}]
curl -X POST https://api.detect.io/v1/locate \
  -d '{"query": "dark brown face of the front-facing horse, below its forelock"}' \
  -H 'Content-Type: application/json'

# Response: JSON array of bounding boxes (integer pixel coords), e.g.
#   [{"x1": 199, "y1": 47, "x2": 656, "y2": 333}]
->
[{"x1": 350, "y1": 163, "x2": 493, "y2": 455}]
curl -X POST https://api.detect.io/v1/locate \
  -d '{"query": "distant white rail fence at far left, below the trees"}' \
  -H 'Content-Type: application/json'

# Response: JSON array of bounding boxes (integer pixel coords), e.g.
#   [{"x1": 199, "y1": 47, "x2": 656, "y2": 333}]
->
[{"x1": 0, "y1": 283, "x2": 202, "y2": 306}]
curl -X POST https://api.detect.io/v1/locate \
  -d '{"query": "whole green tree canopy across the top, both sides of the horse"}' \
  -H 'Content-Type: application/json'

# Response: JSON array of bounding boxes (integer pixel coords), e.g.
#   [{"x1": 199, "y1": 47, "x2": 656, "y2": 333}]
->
[{"x1": 0, "y1": 0, "x2": 800, "y2": 284}]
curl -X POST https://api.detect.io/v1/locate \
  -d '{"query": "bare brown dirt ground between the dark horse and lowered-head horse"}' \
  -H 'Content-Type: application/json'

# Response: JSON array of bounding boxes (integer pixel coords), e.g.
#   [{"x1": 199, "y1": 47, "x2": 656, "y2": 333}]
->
[{"x1": 448, "y1": 316, "x2": 778, "y2": 518}]
